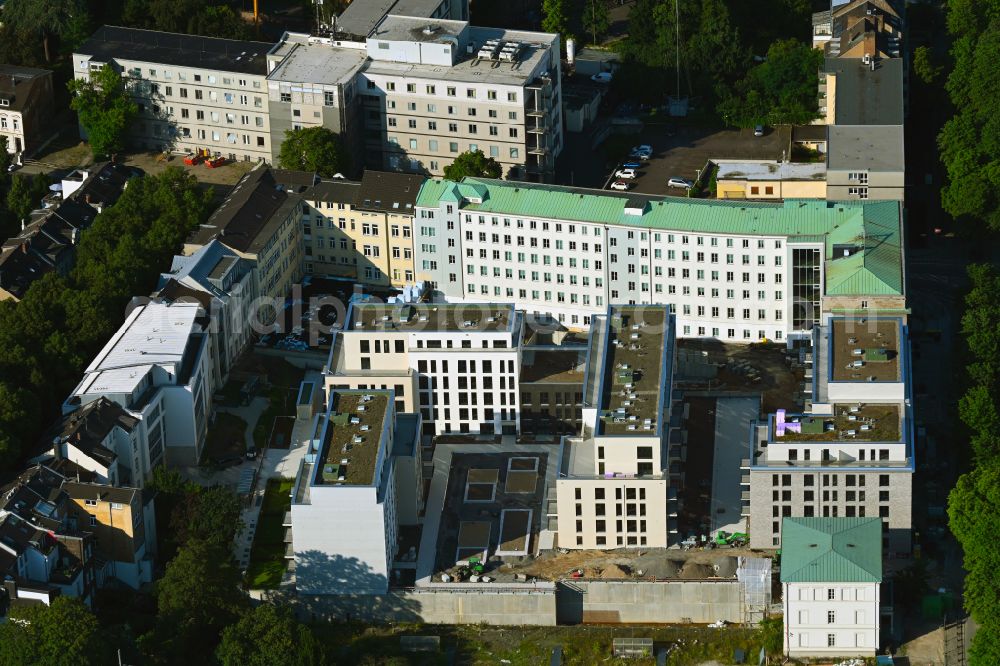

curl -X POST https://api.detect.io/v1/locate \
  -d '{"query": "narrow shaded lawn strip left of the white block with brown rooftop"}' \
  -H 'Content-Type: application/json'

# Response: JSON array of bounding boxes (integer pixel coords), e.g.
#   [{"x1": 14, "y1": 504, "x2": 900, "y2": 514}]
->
[{"x1": 246, "y1": 479, "x2": 295, "y2": 589}]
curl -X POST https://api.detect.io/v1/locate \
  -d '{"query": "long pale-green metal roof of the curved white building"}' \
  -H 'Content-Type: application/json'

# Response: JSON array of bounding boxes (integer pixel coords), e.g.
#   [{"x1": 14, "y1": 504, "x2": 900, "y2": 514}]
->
[{"x1": 417, "y1": 178, "x2": 903, "y2": 296}]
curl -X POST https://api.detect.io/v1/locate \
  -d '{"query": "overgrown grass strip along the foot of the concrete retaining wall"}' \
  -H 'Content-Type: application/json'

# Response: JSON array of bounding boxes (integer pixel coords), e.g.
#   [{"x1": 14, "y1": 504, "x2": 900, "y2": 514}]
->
[{"x1": 314, "y1": 623, "x2": 781, "y2": 666}]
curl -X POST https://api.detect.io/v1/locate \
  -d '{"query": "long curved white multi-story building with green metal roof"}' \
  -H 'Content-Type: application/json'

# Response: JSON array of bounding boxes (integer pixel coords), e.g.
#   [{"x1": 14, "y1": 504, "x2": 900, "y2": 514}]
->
[{"x1": 413, "y1": 178, "x2": 905, "y2": 342}]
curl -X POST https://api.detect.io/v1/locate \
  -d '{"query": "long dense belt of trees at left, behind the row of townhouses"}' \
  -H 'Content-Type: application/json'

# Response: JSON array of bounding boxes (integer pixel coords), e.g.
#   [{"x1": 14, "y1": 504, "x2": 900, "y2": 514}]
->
[{"x1": 0, "y1": 167, "x2": 212, "y2": 472}]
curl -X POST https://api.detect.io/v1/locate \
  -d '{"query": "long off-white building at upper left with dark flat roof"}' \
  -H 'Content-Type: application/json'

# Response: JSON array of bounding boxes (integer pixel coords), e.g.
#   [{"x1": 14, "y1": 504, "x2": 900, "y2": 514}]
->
[{"x1": 73, "y1": 26, "x2": 273, "y2": 161}]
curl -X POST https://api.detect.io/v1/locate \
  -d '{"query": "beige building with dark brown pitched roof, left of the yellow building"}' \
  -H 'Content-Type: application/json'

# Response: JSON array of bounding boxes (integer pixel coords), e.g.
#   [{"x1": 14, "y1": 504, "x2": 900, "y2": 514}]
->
[{"x1": 184, "y1": 165, "x2": 306, "y2": 304}]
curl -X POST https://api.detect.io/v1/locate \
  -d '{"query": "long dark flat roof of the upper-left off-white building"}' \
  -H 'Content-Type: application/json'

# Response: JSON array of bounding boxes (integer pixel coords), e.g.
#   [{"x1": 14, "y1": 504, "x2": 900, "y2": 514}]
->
[{"x1": 74, "y1": 25, "x2": 274, "y2": 76}]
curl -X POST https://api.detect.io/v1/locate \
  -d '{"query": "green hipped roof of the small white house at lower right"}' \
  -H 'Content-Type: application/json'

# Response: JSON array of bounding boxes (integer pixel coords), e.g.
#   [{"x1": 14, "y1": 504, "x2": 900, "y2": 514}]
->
[{"x1": 781, "y1": 518, "x2": 882, "y2": 583}]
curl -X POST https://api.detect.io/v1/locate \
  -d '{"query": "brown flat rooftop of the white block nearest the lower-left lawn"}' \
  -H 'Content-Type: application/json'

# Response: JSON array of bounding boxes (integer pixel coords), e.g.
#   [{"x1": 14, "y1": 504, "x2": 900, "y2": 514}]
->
[{"x1": 316, "y1": 390, "x2": 389, "y2": 486}]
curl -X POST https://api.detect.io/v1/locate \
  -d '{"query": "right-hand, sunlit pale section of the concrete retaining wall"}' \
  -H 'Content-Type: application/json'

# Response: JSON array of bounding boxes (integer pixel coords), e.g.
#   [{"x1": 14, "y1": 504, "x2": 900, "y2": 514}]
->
[{"x1": 556, "y1": 580, "x2": 743, "y2": 624}]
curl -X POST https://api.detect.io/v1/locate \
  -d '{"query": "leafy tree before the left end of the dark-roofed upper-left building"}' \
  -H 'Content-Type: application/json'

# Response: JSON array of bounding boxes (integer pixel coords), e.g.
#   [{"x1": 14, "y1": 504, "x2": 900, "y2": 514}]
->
[{"x1": 68, "y1": 65, "x2": 139, "y2": 157}]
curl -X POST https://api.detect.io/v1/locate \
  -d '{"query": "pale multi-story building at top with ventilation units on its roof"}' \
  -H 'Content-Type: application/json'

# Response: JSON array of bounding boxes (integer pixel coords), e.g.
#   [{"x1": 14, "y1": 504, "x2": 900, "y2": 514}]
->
[{"x1": 358, "y1": 16, "x2": 563, "y2": 181}]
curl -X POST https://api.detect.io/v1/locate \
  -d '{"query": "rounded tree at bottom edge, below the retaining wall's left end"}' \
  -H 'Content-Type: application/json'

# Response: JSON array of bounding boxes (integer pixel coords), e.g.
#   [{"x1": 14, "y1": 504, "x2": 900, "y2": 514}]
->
[{"x1": 215, "y1": 603, "x2": 323, "y2": 666}]
